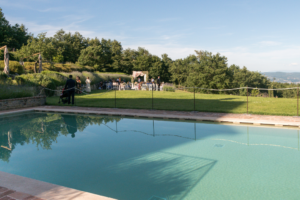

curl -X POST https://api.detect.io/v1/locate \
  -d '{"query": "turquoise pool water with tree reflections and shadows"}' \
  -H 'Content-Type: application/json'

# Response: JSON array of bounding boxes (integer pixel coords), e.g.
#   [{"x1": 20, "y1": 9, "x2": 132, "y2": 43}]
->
[{"x1": 0, "y1": 112, "x2": 300, "y2": 200}]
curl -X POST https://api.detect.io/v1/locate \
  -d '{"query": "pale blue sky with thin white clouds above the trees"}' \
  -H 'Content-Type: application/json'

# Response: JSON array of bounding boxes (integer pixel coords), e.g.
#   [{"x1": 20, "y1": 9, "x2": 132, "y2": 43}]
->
[{"x1": 0, "y1": 0, "x2": 300, "y2": 72}]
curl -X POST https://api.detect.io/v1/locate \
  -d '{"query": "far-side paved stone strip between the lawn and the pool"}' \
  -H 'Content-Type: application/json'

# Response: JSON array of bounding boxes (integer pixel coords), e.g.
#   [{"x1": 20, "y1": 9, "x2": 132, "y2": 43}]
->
[{"x1": 0, "y1": 106, "x2": 300, "y2": 128}]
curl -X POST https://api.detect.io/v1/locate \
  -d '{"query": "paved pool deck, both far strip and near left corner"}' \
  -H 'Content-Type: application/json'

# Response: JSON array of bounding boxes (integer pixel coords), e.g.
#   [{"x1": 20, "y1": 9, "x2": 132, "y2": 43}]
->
[{"x1": 0, "y1": 106, "x2": 300, "y2": 200}]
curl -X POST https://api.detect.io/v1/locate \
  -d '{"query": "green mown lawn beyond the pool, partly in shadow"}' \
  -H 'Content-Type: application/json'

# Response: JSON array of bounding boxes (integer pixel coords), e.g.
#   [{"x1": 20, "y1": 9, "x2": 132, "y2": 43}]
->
[{"x1": 47, "y1": 90, "x2": 297, "y2": 116}]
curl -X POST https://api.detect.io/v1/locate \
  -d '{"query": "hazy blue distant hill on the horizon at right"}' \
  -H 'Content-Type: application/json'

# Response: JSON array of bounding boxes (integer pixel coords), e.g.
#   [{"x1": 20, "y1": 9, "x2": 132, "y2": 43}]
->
[{"x1": 262, "y1": 72, "x2": 300, "y2": 83}]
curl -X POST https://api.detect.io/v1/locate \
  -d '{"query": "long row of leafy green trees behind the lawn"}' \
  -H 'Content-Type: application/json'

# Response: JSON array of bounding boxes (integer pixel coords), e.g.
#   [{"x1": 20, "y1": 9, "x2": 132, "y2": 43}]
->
[{"x1": 0, "y1": 7, "x2": 276, "y2": 91}]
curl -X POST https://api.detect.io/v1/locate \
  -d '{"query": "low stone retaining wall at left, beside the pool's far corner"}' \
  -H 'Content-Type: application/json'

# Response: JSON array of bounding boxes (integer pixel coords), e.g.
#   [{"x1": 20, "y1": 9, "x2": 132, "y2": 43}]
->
[{"x1": 0, "y1": 96, "x2": 46, "y2": 110}]
